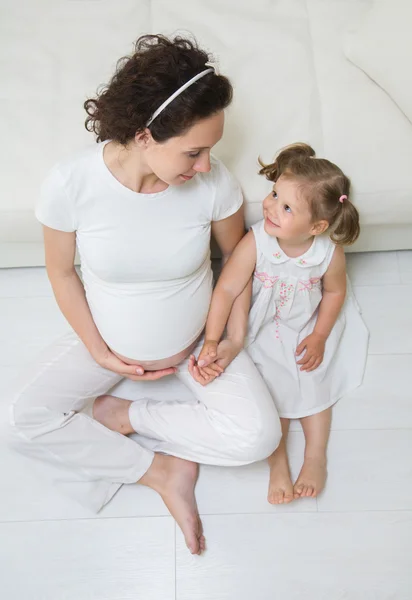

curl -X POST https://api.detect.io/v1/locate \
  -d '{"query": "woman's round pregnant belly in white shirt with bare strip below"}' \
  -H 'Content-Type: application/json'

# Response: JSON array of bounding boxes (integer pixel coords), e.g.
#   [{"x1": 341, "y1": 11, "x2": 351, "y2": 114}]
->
[{"x1": 86, "y1": 262, "x2": 213, "y2": 370}]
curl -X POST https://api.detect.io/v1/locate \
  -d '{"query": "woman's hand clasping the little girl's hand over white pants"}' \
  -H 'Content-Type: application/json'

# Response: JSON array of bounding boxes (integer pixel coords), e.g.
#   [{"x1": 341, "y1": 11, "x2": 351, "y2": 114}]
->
[{"x1": 189, "y1": 338, "x2": 243, "y2": 385}]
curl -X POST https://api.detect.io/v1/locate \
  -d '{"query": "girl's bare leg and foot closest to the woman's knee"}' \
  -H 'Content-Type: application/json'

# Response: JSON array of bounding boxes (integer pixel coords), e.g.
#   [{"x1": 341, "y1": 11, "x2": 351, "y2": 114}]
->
[{"x1": 268, "y1": 418, "x2": 293, "y2": 504}]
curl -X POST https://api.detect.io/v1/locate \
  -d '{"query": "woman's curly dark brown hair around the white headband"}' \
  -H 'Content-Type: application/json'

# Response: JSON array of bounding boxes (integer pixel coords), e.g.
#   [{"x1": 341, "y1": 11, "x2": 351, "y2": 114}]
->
[{"x1": 84, "y1": 35, "x2": 233, "y2": 144}]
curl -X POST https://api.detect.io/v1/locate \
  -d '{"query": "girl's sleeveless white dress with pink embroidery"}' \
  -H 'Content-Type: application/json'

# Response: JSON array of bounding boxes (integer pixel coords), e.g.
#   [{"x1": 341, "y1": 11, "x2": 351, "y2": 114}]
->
[{"x1": 247, "y1": 221, "x2": 369, "y2": 419}]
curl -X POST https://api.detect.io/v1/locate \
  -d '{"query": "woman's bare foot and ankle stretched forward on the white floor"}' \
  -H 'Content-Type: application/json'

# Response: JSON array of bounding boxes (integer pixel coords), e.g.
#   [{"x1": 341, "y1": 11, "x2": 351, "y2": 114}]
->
[{"x1": 139, "y1": 454, "x2": 206, "y2": 554}]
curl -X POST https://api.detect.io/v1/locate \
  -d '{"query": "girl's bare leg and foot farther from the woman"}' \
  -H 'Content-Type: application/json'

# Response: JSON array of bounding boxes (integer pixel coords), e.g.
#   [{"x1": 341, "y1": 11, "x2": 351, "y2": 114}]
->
[{"x1": 293, "y1": 408, "x2": 332, "y2": 498}]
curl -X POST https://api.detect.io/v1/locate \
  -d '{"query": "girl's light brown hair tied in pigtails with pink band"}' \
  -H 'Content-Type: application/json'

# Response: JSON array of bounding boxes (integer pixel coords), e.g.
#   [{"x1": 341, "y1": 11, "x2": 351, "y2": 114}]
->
[{"x1": 259, "y1": 143, "x2": 360, "y2": 246}]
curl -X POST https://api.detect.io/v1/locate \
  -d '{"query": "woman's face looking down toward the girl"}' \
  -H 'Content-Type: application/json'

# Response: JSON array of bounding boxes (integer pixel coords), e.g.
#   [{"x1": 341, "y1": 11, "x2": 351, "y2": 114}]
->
[{"x1": 145, "y1": 111, "x2": 225, "y2": 185}]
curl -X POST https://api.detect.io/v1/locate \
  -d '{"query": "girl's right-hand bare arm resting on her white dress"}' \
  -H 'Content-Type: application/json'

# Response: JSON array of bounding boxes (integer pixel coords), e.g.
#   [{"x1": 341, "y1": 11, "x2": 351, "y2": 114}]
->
[{"x1": 296, "y1": 246, "x2": 346, "y2": 371}]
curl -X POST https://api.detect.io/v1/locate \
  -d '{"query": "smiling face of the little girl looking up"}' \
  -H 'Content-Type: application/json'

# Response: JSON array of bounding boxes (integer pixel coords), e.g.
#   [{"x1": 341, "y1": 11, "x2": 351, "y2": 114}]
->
[{"x1": 263, "y1": 175, "x2": 319, "y2": 243}]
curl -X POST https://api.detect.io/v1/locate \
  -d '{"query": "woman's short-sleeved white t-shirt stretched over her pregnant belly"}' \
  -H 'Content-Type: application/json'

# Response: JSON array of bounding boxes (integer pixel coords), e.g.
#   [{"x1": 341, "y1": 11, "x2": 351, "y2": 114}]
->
[{"x1": 36, "y1": 142, "x2": 243, "y2": 361}]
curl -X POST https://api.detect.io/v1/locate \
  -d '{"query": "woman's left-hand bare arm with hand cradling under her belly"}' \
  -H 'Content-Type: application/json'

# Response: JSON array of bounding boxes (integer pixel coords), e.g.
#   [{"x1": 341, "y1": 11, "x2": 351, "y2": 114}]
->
[{"x1": 43, "y1": 226, "x2": 175, "y2": 381}]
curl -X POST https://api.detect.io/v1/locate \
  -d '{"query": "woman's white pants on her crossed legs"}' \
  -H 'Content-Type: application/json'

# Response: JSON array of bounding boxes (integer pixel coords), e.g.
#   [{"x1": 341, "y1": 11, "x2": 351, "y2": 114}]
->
[{"x1": 11, "y1": 333, "x2": 281, "y2": 510}]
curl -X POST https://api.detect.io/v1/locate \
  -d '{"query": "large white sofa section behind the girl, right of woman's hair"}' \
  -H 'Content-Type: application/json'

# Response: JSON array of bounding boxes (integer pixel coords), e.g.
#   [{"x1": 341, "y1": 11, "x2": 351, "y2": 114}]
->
[{"x1": 156, "y1": 0, "x2": 412, "y2": 231}]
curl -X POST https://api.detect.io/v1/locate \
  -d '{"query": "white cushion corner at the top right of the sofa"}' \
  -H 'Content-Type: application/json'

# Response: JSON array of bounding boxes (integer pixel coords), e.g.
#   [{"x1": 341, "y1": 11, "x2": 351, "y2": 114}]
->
[{"x1": 345, "y1": 0, "x2": 412, "y2": 122}]
